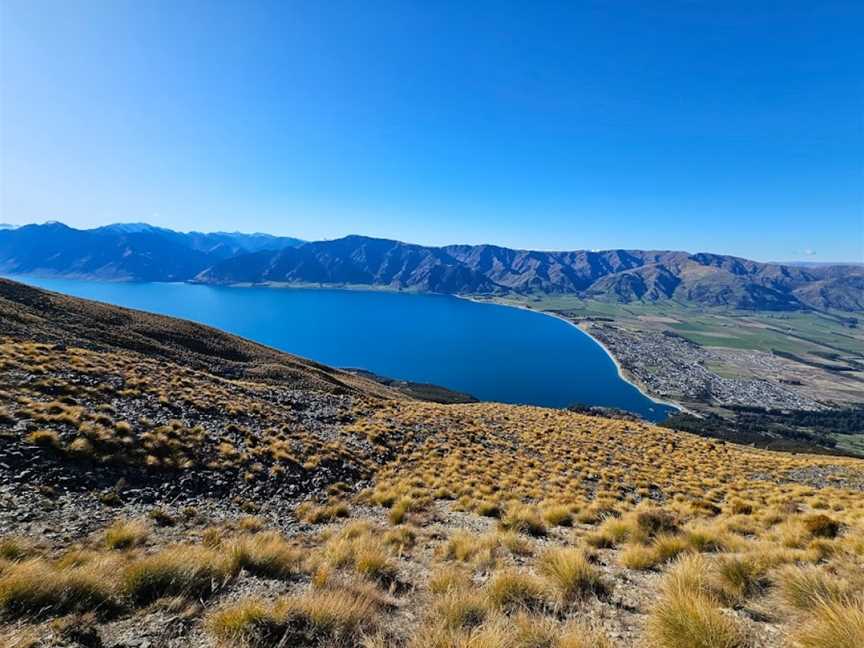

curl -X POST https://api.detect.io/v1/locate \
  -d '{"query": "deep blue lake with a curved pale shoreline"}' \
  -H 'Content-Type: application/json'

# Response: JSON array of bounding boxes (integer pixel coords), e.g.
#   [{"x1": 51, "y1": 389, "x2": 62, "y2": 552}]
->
[{"x1": 12, "y1": 277, "x2": 672, "y2": 421}]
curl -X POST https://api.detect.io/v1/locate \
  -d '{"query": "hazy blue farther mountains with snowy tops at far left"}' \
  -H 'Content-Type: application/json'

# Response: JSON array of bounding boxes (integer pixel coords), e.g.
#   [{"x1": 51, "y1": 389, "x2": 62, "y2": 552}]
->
[{"x1": 0, "y1": 222, "x2": 301, "y2": 281}]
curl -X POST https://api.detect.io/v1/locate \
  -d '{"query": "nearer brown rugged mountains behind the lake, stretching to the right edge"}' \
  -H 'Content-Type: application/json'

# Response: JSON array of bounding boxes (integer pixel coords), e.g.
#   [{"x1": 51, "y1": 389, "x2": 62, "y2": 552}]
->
[{"x1": 195, "y1": 236, "x2": 864, "y2": 310}]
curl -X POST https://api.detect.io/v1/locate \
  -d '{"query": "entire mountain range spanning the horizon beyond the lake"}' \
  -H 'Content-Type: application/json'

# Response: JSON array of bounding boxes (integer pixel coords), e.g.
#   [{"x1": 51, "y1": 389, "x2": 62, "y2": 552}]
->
[{"x1": 0, "y1": 223, "x2": 864, "y2": 311}]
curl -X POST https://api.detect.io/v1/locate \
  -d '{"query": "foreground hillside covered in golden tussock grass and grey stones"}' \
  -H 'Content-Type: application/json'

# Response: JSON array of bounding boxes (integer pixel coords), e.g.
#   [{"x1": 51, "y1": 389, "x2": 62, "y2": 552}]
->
[{"x1": 0, "y1": 280, "x2": 864, "y2": 648}]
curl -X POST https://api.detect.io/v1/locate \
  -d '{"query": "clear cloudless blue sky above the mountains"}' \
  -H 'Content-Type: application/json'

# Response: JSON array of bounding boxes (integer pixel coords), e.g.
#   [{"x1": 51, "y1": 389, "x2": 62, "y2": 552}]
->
[{"x1": 0, "y1": 0, "x2": 864, "y2": 261}]
